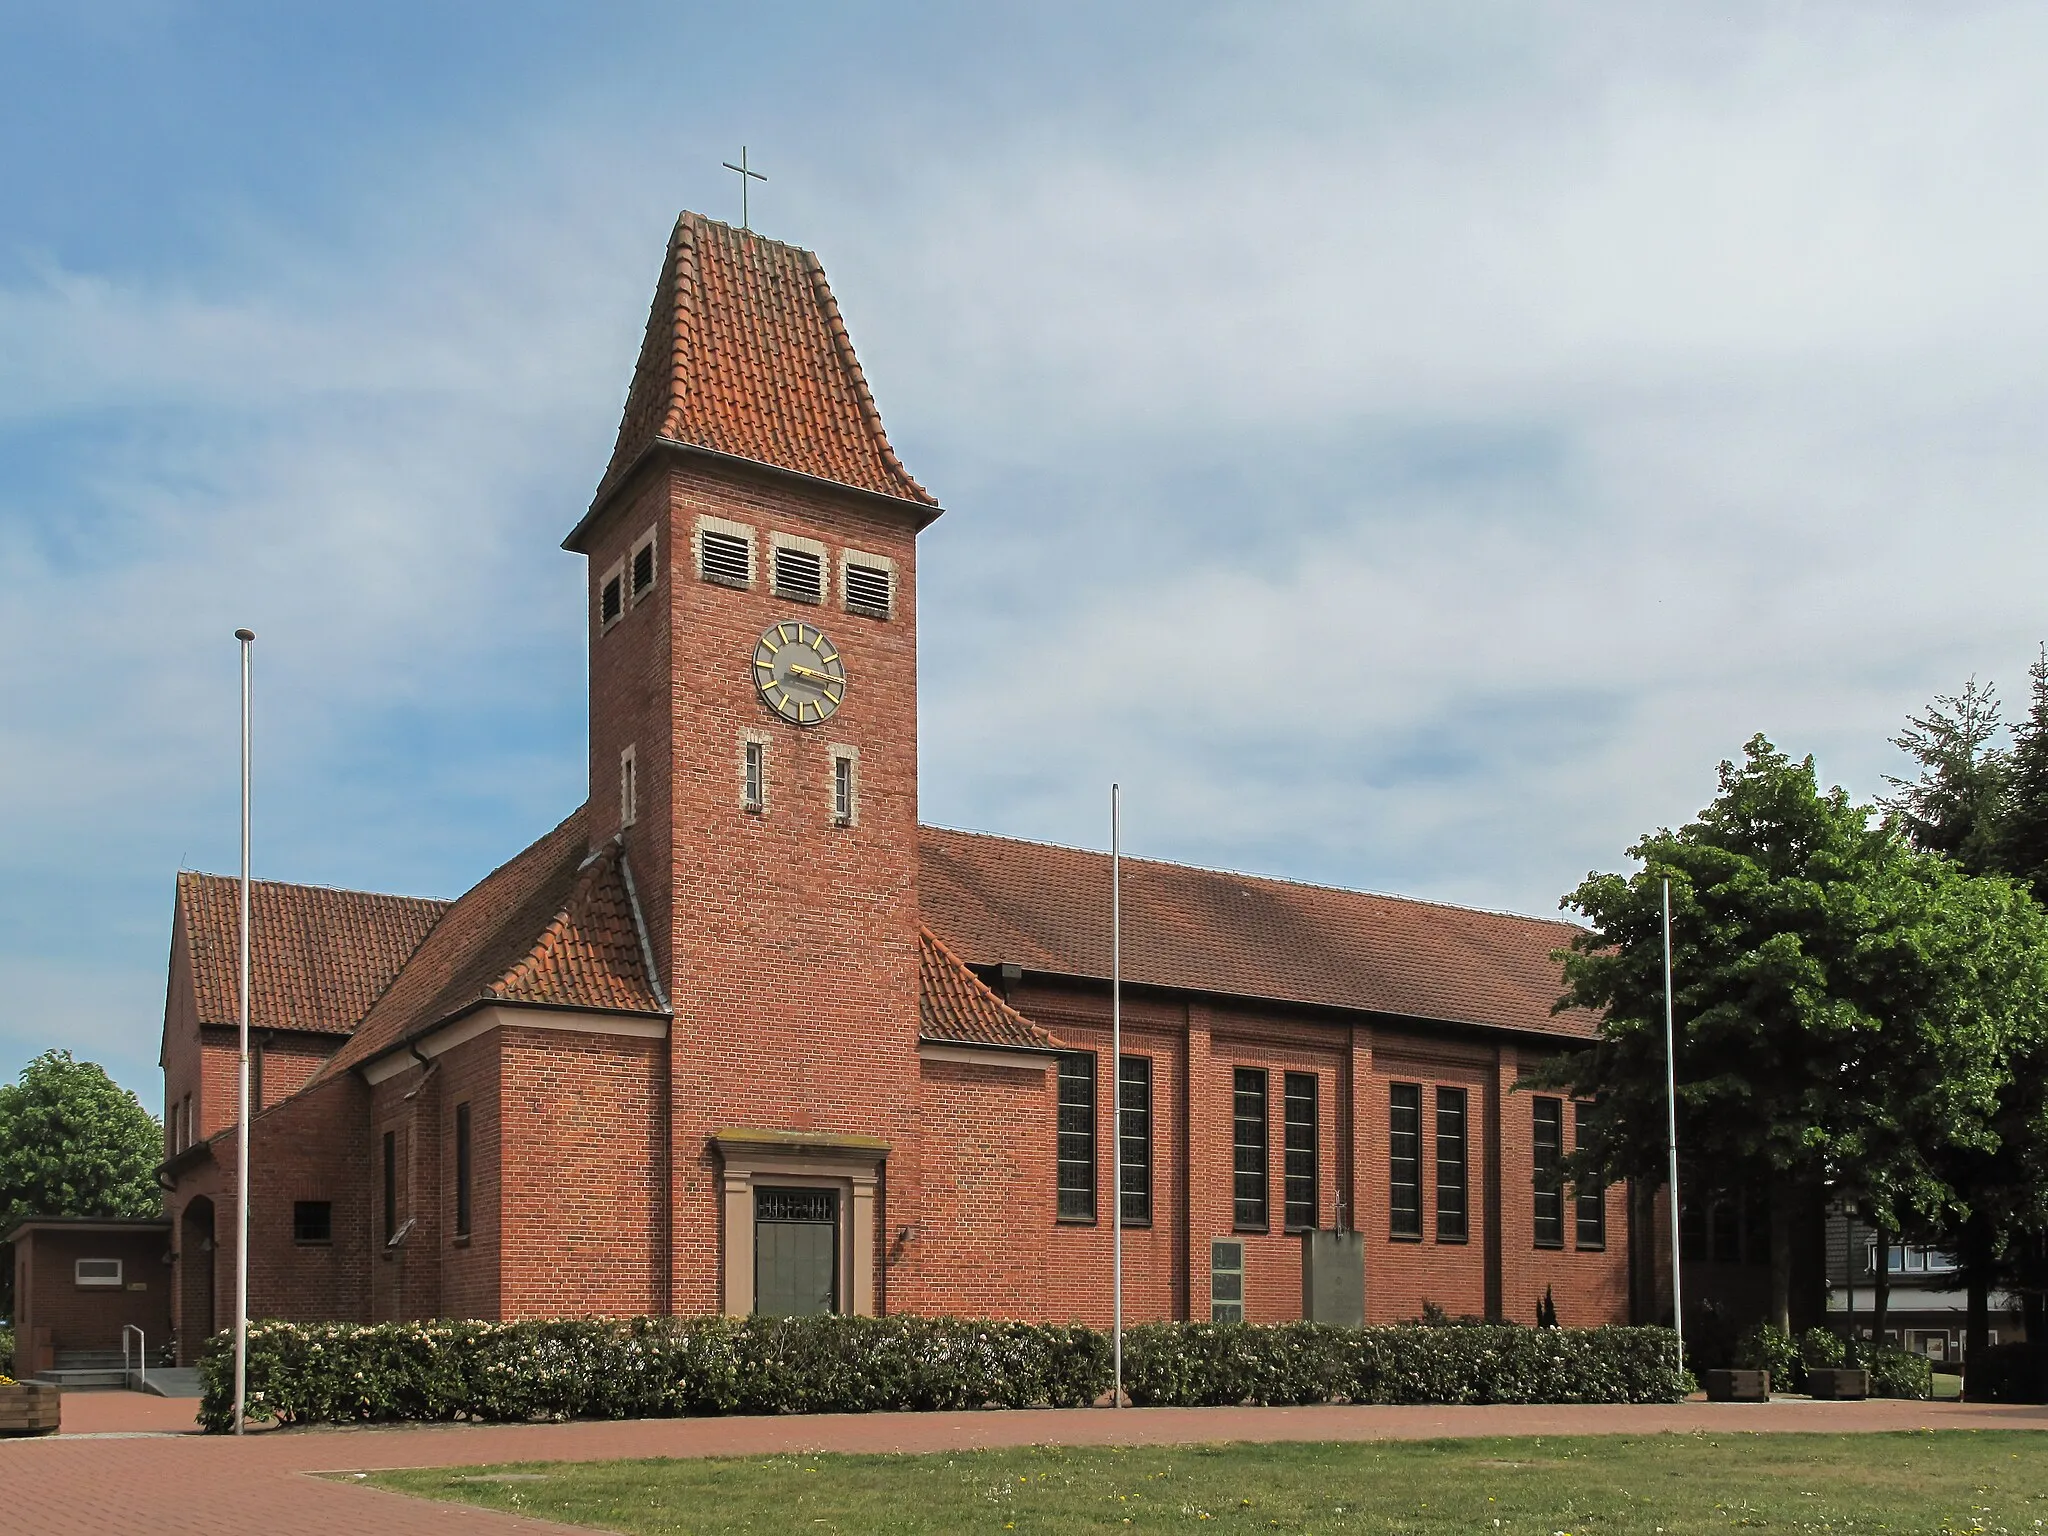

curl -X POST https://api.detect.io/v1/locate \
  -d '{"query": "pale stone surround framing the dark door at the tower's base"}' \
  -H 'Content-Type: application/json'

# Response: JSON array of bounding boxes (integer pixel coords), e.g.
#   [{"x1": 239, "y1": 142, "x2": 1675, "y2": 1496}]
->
[{"x1": 711, "y1": 1128, "x2": 889, "y2": 1317}]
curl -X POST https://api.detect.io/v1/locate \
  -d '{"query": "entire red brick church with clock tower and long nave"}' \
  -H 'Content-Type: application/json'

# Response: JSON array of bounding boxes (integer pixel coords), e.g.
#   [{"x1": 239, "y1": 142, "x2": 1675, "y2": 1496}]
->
[{"x1": 140, "y1": 215, "x2": 1649, "y2": 1360}]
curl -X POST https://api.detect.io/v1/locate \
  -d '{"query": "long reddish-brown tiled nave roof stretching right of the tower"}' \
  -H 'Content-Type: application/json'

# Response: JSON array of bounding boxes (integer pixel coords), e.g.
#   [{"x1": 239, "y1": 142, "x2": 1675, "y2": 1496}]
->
[{"x1": 920, "y1": 827, "x2": 1595, "y2": 1036}]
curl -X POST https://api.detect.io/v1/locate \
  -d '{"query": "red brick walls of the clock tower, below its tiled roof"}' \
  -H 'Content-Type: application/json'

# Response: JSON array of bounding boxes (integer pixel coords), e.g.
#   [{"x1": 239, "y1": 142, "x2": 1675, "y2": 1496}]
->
[{"x1": 581, "y1": 459, "x2": 922, "y2": 1313}]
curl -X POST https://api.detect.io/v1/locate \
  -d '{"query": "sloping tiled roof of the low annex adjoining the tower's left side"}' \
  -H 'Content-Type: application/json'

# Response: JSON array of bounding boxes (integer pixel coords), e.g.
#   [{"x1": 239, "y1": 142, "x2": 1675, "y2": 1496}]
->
[{"x1": 319, "y1": 809, "x2": 666, "y2": 1077}]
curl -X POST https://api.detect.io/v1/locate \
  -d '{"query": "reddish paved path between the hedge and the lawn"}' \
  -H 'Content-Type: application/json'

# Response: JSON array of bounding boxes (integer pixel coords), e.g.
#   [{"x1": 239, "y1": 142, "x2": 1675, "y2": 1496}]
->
[{"x1": 0, "y1": 1393, "x2": 2048, "y2": 1536}]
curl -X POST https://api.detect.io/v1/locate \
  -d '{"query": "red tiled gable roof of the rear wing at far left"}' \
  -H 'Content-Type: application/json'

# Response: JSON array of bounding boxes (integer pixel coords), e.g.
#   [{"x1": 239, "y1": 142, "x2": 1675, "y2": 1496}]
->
[{"x1": 176, "y1": 870, "x2": 449, "y2": 1034}]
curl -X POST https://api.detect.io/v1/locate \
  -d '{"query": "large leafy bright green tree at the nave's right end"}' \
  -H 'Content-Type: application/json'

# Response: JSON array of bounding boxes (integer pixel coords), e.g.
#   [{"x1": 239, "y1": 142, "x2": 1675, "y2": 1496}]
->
[{"x1": 1540, "y1": 735, "x2": 2048, "y2": 1327}]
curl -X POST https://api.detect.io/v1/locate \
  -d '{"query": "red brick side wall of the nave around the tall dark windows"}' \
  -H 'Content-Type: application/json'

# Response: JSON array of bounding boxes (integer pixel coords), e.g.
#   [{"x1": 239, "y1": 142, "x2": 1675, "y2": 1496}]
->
[{"x1": 974, "y1": 979, "x2": 1628, "y2": 1325}]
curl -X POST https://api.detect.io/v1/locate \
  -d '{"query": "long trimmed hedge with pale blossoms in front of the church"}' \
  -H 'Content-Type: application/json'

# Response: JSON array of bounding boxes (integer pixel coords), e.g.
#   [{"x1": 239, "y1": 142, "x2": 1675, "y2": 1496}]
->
[{"x1": 199, "y1": 1317, "x2": 1686, "y2": 1432}]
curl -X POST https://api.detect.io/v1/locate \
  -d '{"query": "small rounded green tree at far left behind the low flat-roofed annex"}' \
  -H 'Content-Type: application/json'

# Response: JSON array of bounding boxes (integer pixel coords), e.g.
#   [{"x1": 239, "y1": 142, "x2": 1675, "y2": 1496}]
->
[{"x1": 0, "y1": 1051, "x2": 164, "y2": 1311}]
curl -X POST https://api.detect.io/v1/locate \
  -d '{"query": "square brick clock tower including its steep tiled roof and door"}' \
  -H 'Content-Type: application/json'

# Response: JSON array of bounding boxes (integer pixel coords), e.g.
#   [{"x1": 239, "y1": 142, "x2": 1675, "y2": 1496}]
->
[{"x1": 565, "y1": 213, "x2": 940, "y2": 1313}]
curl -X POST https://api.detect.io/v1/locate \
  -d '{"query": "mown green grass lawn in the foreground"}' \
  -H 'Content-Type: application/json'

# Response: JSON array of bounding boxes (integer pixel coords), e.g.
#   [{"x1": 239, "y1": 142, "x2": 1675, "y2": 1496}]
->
[{"x1": 369, "y1": 1432, "x2": 2048, "y2": 1536}]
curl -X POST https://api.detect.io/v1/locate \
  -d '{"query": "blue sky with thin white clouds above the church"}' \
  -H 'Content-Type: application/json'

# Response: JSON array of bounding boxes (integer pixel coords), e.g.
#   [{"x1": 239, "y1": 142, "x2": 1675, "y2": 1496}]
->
[{"x1": 0, "y1": 0, "x2": 2048, "y2": 1106}]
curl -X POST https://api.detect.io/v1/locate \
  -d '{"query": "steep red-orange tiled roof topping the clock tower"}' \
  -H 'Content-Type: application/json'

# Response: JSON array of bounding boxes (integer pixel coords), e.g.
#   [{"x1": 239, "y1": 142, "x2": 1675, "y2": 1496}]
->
[{"x1": 571, "y1": 213, "x2": 938, "y2": 520}]
